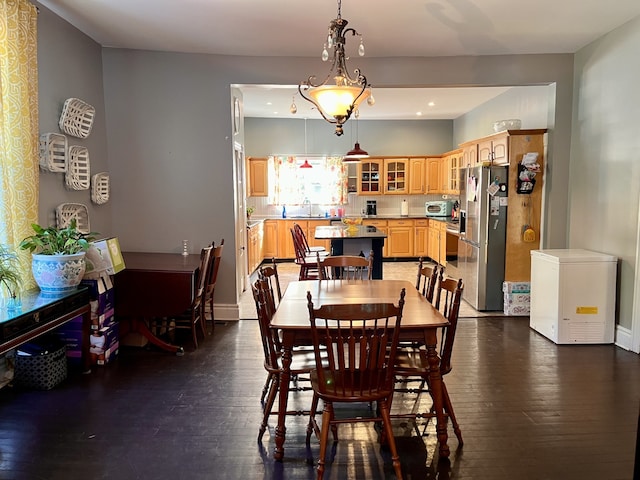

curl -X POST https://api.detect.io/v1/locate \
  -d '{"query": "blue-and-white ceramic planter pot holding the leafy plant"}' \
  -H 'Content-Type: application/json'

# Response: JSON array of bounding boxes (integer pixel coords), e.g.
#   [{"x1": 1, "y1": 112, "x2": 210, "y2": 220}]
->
[{"x1": 31, "y1": 252, "x2": 85, "y2": 295}]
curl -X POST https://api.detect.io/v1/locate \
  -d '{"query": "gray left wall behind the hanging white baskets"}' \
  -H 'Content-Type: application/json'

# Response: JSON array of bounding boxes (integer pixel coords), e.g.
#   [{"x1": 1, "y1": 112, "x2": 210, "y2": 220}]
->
[{"x1": 38, "y1": 6, "x2": 112, "y2": 236}]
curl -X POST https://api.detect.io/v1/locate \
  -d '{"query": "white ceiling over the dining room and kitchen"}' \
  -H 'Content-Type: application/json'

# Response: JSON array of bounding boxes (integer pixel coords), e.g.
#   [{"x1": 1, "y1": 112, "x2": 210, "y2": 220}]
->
[{"x1": 40, "y1": 0, "x2": 640, "y2": 119}]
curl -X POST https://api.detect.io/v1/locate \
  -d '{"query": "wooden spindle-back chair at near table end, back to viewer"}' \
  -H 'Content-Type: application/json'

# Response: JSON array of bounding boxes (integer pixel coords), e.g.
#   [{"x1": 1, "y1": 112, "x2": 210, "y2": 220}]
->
[{"x1": 307, "y1": 289, "x2": 405, "y2": 479}]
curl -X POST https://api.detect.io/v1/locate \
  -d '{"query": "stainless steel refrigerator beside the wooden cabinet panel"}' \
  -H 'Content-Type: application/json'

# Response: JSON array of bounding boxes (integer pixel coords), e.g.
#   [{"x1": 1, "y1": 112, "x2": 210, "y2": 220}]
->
[{"x1": 458, "y1": 166, "x2": 508, "y2": 311}]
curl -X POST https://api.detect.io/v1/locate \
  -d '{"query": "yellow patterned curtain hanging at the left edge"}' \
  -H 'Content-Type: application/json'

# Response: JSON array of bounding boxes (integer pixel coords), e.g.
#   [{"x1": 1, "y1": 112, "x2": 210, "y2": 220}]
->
[{"x1": 0, "y1": 0, "x2": 39, "y2": 288}]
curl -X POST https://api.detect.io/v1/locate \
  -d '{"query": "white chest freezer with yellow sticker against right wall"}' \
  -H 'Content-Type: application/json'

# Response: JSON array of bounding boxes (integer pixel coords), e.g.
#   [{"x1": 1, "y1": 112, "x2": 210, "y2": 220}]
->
[{"x1": 529, "y1": 249, "x2": 617, "y2": 344}]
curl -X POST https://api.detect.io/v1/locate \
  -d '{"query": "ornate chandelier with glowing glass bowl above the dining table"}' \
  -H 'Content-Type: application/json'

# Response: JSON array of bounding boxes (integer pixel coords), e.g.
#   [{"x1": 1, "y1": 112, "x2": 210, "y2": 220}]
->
[{"x1": 298, "y1": 0, "x2": 373, "y2": 136}]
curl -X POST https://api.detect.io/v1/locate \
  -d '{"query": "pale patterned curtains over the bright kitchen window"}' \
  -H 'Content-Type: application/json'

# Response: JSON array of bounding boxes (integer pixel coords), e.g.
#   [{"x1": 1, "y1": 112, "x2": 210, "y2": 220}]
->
[{"x1": 267, "y1": 156, "x2": 348, "y2": 205}]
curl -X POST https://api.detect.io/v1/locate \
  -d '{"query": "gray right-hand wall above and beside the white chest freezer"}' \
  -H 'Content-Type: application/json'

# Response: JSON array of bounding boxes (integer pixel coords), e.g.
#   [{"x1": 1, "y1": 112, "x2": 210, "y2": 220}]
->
[{"x1": 569, "y1": 18, "x2": 640, "y2": 328}]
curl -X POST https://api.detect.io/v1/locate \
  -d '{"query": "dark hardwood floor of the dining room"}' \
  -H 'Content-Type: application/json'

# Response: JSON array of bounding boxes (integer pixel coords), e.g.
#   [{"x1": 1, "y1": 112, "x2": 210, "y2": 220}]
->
[{"x1": 0, "y1": 317, "x2": 640, "y2": 480}]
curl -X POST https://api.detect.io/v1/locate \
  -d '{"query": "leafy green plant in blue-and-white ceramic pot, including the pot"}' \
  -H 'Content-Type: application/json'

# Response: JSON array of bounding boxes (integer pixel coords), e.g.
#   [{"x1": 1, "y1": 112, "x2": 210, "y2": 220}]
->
[{"x1": 20, "y1": 219, "x2": 97, "y2": 294}]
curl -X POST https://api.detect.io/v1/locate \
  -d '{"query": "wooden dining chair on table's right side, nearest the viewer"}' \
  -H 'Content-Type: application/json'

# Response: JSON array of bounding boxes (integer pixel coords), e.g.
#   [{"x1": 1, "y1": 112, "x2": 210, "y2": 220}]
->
[{"x1": 394, "y1": 270, "x2": 464, "y2": 445}]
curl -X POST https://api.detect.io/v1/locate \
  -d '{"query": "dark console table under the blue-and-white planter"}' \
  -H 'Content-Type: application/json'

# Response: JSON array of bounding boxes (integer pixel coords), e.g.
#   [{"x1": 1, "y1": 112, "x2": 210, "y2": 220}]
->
[{"x1": 0, "y1": 286, "x2": 91, "y2": 373}]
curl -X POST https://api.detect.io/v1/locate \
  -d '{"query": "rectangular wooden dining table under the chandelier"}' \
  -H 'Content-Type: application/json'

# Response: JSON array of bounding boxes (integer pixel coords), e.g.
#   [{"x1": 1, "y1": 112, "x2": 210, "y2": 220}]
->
[{"x1": 271, "y1": 280, "x2": 450, "y2": 461}]
